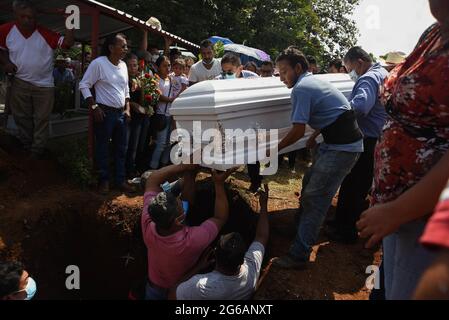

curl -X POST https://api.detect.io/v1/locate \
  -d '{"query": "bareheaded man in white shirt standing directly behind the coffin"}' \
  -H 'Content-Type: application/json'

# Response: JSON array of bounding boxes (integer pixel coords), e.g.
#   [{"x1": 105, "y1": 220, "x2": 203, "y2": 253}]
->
[{"x1": 189, "y1": 40, "x2": 222, "y2": 86}]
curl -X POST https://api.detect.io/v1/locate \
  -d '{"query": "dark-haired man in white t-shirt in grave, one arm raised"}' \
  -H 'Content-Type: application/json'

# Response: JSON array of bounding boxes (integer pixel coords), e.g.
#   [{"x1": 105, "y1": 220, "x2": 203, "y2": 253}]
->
[{"x1": 169, "y1": 185, "x2": 270, "y2": 300}]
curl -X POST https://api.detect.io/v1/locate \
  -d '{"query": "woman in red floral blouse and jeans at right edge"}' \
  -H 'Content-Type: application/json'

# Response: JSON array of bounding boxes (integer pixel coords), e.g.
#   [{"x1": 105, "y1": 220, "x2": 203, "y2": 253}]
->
[{"x1": 358, "y1": 0, "x2": 449, "y2": 299}]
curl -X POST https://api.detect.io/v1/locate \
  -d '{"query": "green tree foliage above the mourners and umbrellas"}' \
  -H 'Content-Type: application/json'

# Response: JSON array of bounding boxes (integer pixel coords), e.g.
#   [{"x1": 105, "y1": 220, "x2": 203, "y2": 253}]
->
[{"x1": 103, "y1": 0, "x2": 359, "y2": 65}]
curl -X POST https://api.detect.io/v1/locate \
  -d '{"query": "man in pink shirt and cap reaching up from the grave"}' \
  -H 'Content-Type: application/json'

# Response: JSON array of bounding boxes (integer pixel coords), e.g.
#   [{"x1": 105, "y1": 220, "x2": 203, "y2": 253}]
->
[{"x1": 142, "y1": 165, "x2": 231, "y2": 300}]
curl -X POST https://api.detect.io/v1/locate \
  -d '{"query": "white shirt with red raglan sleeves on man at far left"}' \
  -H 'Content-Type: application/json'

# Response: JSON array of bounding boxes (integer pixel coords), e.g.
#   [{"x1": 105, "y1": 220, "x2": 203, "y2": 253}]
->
[{"x1": 0, "y1": 22, "x2": 64, "y2": 88}]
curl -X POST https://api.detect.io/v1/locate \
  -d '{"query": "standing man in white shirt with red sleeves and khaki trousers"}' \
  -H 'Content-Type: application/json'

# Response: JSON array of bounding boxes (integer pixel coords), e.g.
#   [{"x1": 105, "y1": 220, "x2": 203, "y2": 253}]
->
[{"x1": 0, "y1": 0, "x2": 74, "y2": 158}]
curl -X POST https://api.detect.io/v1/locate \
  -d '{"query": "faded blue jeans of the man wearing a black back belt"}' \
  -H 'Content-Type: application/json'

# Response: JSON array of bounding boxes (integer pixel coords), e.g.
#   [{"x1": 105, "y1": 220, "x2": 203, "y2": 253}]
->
[{"x1": 289, "y1": 150, "x2": 360, "y2": 261}]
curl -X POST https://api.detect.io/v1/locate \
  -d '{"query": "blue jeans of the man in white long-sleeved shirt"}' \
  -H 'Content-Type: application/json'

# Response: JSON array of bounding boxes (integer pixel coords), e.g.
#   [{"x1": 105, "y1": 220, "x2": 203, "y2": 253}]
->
[{"x1": 94, "y1": 109, "x2": 128, "y2": 185}]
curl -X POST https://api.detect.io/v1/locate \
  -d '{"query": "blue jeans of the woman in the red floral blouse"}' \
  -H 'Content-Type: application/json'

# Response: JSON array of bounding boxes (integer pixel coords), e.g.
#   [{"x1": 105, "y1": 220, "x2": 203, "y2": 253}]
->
[{"x1": 383, "y1": 219, "x2": 437, "y2": 300}]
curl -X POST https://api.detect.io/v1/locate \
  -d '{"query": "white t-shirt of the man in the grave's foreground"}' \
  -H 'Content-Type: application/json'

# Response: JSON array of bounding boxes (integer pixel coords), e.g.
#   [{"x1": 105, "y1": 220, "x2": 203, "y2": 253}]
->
[{"x1": 176, "y1": 242, "x2": 265, "y2": 300}]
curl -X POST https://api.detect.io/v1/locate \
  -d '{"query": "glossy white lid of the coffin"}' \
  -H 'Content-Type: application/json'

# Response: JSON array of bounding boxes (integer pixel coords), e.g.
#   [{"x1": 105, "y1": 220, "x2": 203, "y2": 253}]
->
[{"x1": 170, "y1": 74, "x2": 354, "y2": 116}]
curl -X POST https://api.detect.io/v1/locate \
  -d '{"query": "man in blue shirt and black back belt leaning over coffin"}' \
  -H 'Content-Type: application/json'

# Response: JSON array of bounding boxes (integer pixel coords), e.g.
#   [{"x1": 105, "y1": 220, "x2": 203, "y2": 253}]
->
[{"x1": 273, "y1": 47, "x2": 363, "y2": 269}]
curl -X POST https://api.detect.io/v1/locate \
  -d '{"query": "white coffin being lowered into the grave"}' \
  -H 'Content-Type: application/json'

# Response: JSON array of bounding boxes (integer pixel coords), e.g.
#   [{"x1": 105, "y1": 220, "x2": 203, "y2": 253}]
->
[{"x1": 170, "y1": 74, "x2": 354, "y2": 170}]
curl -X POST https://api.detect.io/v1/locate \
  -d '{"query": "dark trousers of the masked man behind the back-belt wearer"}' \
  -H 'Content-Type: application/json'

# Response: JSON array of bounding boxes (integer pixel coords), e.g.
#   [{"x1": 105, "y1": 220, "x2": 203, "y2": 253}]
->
[{"x1": 336, "y1": 138, "x2": 377, "y2": 237}]
